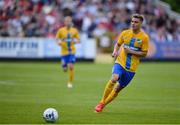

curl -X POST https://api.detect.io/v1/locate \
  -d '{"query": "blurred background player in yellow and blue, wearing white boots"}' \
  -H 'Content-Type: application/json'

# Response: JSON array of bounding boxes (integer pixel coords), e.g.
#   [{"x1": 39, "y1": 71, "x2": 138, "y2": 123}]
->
[{"x1": 56, "y1": 16, "x2": 80, "y2": 88}]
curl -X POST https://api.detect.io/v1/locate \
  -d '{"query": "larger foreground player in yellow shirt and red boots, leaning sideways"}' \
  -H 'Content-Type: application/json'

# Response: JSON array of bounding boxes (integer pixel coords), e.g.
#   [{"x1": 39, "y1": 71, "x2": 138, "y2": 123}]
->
[{"x1": 95, "y1": 14, "x2": 149, "y2": 113}]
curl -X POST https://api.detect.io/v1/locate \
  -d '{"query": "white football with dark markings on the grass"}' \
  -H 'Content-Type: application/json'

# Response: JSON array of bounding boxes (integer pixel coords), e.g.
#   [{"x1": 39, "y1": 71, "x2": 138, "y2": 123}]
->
[{"x1": 43, "y1": 108, "x2": 58, "y2": 123}]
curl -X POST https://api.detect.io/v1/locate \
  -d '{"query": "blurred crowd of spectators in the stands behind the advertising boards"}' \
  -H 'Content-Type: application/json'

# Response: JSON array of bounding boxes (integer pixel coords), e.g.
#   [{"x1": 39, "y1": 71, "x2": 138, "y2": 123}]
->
[{"x1": 0, "y1": 0, "x2": 180, "y2": 42}]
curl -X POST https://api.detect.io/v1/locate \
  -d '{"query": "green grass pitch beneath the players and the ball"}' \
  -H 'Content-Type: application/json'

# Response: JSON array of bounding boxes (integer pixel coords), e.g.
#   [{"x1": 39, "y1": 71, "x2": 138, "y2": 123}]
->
[{"x1": 0, "y1": 62, "x2": 180, "y2": 124}]
